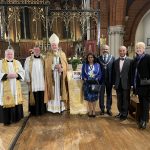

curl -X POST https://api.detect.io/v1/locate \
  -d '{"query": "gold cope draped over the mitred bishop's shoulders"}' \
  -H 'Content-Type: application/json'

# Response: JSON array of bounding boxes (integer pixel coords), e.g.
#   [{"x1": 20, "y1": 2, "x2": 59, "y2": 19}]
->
[{"x1": 44, "y1": 50, "x2": 68, "y2": 103}]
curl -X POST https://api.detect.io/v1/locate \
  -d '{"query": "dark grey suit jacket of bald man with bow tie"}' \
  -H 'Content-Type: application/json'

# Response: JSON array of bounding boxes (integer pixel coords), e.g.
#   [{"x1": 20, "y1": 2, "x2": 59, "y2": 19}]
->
[{"x1": 113, "y1": 57, "x2": 132, "y2": 90}]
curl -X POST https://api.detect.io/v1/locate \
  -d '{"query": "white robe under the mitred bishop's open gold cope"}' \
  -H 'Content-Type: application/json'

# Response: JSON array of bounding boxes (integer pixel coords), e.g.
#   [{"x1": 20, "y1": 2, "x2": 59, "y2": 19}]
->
[{"x1": 47, "y1": 57, "x2": 65, "y2": 113}]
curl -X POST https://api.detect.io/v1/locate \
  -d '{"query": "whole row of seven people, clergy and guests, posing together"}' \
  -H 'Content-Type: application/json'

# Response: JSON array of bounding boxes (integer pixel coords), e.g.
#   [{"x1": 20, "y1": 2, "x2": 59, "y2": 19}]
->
[{"x1": 0, "y1": 34, "x2": 150, "y2": 129}]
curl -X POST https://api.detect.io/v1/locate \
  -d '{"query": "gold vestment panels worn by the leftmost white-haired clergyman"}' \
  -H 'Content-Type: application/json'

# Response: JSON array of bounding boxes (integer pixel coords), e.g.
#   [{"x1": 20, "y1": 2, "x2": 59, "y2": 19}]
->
[{"x1": 2, "y1": 59, "x2": 23, "y2": 108}]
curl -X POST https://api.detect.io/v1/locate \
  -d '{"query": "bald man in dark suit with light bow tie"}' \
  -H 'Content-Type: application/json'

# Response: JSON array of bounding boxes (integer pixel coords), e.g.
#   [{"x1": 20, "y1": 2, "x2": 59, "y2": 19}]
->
[{"x1": 113, "y1": 46, "x2": 132, "y2": 120}]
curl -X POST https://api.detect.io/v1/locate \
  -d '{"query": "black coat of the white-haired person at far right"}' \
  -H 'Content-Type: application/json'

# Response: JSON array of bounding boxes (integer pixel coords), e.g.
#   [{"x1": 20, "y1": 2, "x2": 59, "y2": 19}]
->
[{"x1": 133, "y1": 54, "x2": 150, "y2": 96}]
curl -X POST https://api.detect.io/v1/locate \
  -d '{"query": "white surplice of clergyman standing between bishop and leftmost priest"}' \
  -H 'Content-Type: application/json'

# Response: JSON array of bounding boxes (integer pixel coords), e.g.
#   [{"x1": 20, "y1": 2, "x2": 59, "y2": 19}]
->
[{"x1": 25, "y1": 58, "x2": 45, "y2": 92}]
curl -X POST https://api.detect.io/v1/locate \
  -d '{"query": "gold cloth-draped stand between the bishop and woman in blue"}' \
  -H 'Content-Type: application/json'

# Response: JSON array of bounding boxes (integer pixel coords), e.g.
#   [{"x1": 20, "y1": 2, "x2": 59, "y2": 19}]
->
[{"x1": 67, "y1": 70, "x2": 88, "y2": 114}]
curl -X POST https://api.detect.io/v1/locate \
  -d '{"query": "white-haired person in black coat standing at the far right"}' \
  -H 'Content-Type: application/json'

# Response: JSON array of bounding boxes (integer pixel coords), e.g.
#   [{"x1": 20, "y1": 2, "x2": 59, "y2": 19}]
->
[{"x1": 133, "y1": 42, "x2": 150, "y2": 129}]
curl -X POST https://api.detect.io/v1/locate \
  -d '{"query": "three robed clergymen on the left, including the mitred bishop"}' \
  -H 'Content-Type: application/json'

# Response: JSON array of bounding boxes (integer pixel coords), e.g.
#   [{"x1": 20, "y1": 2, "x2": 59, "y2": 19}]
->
[{"x1": 0, "y1": 34, "x2": 68, "y2": 125}]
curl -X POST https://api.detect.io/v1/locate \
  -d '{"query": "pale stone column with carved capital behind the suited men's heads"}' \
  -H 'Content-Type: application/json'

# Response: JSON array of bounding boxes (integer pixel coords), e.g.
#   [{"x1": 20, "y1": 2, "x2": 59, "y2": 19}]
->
[{"x1": 108, "y1": 25, "x2": 124, "y2": 57}]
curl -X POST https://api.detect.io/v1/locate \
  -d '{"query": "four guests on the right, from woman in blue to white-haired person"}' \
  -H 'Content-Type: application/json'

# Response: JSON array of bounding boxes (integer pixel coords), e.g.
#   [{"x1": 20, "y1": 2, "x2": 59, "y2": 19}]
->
[{"x1": 82, "y1": 42, "x2": 150, "y2": 129}]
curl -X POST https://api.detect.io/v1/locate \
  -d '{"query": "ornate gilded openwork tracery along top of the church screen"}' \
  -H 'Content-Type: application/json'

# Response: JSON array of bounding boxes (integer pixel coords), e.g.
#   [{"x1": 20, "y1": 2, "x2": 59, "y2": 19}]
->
[{"x1": 0, "y1": 0, "x2": 100, "y2": 47}]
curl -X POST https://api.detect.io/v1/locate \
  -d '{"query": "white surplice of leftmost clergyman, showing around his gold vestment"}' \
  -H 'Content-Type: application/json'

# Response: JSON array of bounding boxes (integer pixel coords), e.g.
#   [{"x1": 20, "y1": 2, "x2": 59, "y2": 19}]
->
[{"x1": 0, "y1": 60, "x2": 25, "y2": 106}]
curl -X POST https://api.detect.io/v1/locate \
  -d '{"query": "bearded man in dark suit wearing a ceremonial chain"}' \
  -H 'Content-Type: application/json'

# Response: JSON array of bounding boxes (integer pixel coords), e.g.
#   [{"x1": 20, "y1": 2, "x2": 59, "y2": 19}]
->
[{"x1": 98, "y1": 45, "x2": 115, "y2": 116}]
